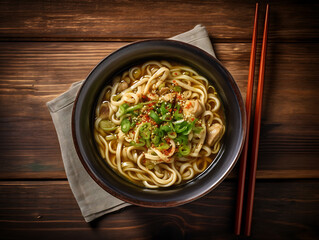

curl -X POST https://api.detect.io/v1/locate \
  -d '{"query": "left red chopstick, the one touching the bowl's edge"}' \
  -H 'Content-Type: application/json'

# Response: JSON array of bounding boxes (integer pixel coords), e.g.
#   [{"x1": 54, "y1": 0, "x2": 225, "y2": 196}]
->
[{"x1": 235, "y1": 3, "x2": 258, "y2": 235}]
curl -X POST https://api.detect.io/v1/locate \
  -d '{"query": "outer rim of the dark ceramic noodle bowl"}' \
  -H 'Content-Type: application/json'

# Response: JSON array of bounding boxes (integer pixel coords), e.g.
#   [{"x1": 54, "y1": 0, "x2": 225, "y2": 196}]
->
[{"x1": 71, "y1": 39, "x2": 247, "y2": 208}]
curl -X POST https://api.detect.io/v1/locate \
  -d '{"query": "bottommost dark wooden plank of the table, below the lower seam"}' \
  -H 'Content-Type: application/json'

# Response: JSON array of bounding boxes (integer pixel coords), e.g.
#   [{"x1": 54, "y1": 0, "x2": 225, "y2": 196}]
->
[{"x1": 0, "y1": 180, "x2": 319, "y2": 240}]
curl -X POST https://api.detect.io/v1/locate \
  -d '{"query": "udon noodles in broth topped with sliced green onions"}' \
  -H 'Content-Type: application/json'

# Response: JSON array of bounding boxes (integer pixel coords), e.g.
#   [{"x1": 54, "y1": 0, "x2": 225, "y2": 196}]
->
[{"x1": 94, "y1": 61, "x2": 225, "y2": 188}]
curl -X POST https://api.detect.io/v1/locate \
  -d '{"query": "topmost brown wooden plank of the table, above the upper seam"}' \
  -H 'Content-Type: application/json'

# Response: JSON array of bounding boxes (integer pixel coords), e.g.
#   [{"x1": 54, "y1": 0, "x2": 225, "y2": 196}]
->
[{"x1": 0, "y1": 0, "x2": 319, "y2": 42}]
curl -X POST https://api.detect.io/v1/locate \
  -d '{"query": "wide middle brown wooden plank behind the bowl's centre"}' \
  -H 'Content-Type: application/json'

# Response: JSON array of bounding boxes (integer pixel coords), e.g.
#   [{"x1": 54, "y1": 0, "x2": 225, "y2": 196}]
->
[{"x1": 0, "y1": 42, "x2": 319, "y2": 179}]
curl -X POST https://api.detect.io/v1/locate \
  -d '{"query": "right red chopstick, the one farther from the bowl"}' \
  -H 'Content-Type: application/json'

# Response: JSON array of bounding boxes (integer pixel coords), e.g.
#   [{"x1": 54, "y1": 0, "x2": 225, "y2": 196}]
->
[{"x1": 244, "y1": 4, "x2": 269, "y2": 236}]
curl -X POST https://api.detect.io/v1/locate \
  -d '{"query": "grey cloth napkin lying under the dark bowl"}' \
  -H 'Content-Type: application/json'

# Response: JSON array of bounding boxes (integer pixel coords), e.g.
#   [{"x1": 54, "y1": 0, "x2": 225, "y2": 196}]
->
[{"x1": 47, "y1": 25, "x2": 215, "y2": 222}]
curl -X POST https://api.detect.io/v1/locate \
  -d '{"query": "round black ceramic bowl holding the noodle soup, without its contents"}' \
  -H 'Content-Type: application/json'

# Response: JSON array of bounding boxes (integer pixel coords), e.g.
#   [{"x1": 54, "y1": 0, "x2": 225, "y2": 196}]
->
[{"x1": 72, "y1": 40, "x2": 246, "y2": 207}]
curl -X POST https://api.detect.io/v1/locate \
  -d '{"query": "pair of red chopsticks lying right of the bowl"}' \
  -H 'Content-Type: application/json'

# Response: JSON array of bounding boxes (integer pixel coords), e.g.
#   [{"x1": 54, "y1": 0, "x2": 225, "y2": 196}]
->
[{"x1": 235, "y1": 3, "x2": 269, "y2": 236}]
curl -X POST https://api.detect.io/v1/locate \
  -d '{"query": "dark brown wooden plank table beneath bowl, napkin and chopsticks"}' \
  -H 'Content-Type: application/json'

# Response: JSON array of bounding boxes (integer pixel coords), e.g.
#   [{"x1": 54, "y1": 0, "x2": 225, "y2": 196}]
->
[{"x1": 0, "y1": 0, "x2": 319, "y2": 239}]
